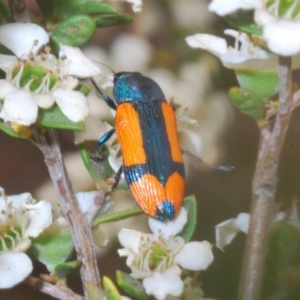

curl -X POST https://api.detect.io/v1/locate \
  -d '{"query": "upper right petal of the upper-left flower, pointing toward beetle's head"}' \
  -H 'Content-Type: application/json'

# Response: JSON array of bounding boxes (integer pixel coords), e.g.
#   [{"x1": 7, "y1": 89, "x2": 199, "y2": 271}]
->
[{"x1": 59, "y1": 45, "x2": 101, "y2": 78}]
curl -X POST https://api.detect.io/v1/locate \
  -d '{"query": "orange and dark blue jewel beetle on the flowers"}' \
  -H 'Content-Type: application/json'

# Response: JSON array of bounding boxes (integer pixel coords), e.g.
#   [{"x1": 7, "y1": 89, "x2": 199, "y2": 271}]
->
[{"x1": 92, "y1": 72, "x2": 185, "y2": 221}]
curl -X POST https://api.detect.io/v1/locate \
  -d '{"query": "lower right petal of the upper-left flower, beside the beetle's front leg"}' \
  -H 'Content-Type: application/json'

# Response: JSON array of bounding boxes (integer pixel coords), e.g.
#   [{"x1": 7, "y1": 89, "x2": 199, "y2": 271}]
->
[{"x1": 52, "y1": 88, "x2": 89, "y2": 122}]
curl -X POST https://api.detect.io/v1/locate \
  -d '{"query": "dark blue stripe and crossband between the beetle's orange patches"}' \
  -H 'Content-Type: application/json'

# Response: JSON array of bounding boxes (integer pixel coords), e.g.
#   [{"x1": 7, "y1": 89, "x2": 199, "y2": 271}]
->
[{"x1": 124, "y1": 100, "x2": 184, "y2": 185}]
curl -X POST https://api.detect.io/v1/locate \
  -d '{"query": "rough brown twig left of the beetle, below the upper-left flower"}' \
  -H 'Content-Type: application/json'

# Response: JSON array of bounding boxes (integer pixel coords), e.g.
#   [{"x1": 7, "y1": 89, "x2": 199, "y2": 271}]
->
[{"x1": 33, "y1": 127, "x2": 101, "y2": 299}]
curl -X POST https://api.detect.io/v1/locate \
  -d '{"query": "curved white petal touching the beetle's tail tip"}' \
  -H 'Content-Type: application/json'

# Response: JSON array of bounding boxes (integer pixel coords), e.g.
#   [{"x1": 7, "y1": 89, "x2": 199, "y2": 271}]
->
[{"x1": 148, "y1": 207, "x2": 187, "y2": 238}]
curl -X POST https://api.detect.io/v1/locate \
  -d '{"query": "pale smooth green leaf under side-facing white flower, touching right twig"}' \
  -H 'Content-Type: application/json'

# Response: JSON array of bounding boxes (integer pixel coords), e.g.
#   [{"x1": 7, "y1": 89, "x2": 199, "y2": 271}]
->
[{"x1": 236, "y1": 69, "x2": 278, "y2": 103}]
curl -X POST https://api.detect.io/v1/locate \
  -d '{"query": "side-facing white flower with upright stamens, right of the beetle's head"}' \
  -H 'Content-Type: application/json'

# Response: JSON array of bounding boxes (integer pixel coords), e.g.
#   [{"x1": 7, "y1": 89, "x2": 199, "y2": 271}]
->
[{"x1": 186, "y1": 29, "x2": 277, "y2": 70}]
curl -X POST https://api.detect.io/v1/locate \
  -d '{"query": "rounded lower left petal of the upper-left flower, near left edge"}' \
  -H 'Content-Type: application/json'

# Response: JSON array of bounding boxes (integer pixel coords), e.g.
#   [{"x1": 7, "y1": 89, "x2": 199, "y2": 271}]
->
[{"x1": 0, "y1": 90, "x2": 38, "y2": 126}]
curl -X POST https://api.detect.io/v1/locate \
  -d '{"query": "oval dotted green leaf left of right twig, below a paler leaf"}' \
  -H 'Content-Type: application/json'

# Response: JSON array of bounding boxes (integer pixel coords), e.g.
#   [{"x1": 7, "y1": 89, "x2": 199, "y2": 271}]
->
[{"x1": 229, "y1": 87, "x2": 264, "y2": 124}]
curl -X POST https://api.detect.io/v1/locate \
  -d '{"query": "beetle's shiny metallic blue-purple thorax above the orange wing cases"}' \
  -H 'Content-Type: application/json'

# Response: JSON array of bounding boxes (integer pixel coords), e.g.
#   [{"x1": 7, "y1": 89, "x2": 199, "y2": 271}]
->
[{"x1": 113, "y1": 72, "x2": 165, "y2": 103}]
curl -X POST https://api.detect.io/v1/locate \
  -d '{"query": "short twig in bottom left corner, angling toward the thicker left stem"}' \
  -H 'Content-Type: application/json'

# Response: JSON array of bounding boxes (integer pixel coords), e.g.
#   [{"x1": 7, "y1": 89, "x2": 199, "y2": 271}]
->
[{"x1": 25, "y1": 276, "x2": 83, "y2": 300}]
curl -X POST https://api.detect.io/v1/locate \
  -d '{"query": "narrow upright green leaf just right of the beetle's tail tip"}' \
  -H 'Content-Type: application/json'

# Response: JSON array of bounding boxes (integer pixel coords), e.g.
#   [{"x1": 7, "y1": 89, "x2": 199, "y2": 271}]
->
[{"x1": 180, "y1": 195, "x2": 197, "y2": 242}]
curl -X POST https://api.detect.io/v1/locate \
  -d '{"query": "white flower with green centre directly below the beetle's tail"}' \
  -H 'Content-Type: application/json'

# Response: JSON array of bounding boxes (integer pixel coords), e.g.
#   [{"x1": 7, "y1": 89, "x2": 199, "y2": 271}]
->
[{"x1": 118, "y1": 208, "x2": 213, "y2": 300}]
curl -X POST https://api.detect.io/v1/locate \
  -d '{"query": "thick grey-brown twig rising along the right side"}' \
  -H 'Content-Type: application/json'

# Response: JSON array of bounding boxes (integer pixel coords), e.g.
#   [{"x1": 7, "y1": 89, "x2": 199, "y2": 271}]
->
[{"x1": 239, "y1": 57, "x2": 294, "y2": 300}]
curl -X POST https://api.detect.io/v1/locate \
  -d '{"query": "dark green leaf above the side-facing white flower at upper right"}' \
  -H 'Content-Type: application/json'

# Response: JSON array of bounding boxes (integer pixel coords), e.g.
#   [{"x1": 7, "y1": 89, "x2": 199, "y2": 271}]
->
[{"x1": 224, "y1": 10, "x2": 262, "y2": 35}]
